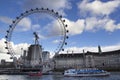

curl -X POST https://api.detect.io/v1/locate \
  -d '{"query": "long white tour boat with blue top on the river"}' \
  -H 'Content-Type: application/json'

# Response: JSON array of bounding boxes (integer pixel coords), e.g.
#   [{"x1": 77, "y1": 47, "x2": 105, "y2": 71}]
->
[{"x1": 64, "y1": 68, "x2": 110, "y2": 77}]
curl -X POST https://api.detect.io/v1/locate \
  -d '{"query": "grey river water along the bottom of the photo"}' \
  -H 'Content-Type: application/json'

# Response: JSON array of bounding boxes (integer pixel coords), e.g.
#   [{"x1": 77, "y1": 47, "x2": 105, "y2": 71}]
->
[{"x1": 0, "y1": 72, "x2": 120, "y2": 80}]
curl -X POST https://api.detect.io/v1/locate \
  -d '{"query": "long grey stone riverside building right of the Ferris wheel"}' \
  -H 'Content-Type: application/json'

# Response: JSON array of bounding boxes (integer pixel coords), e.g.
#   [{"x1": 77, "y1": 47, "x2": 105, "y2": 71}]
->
[{"x1": 53, "y1": 50, "x2": 120, "y2": 70}]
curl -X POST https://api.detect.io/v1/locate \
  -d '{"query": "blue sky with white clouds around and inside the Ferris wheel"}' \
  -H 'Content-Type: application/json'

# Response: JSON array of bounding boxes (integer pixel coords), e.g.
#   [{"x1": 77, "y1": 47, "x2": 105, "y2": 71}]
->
[{"x1": 0, "y1": 0, "x2": 120, "y2": 60}]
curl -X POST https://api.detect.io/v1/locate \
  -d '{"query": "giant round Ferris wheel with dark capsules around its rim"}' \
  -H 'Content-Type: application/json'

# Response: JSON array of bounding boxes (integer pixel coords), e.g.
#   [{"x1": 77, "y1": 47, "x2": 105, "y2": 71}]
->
[{"x1": 5, "y1": 8, "x2": 69, "y2": 59}]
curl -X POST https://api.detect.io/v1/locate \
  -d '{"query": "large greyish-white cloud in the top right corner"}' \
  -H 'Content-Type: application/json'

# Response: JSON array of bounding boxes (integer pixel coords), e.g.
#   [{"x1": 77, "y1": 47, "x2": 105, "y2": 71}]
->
[{"x1": 78, "y1": 0, "x2": 120, "y2": 15}]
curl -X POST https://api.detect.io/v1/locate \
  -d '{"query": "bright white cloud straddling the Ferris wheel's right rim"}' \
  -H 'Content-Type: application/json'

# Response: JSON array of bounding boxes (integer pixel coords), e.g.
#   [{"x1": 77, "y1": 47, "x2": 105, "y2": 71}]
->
[{"x1": 45, "y1": 18, "x2": 85, "y2": 37}]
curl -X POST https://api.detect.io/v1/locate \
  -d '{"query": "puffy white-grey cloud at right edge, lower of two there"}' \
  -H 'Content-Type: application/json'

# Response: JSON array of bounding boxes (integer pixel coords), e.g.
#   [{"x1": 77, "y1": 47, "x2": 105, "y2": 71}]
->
[{"x1": 85, "y1": 17, "x2": 120, "y2": 32}]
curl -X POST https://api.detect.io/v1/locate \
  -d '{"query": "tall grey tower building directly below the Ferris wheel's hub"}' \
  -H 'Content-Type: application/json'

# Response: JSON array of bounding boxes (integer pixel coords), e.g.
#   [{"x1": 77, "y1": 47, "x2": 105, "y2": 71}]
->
[{"x1": 26, "y1": 45, "x2": 42, "y2": 67}]
